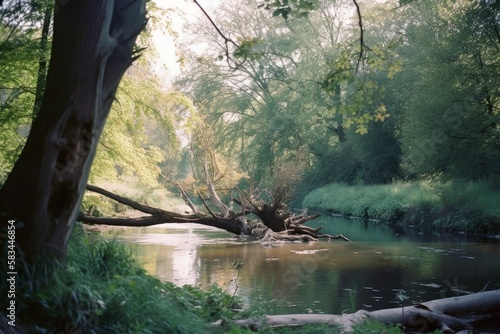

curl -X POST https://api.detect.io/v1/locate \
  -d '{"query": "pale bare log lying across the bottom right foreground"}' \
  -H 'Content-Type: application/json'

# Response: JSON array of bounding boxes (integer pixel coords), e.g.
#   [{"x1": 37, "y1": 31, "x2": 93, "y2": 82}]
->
[{"x1": 211, "y1": 290, "x2": 500, "y2": 333}]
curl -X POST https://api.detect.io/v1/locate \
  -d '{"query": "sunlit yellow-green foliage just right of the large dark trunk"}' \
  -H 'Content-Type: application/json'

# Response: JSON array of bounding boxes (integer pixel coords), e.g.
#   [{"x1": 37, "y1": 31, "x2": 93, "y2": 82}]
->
[{"x1": 90, "y1": 74, "x2": 184, "y2": 186}]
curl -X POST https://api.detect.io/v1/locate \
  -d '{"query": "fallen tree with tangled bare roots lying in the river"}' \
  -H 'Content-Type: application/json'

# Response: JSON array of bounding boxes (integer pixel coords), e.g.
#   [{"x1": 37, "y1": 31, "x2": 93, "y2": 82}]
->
[{"x1": 78, "y1": 181, "x2": 350, "y2": 242}]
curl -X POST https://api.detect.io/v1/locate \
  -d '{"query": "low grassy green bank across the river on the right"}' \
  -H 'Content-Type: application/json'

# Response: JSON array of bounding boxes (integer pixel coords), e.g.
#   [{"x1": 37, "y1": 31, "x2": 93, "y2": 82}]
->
[{"x1": 302, "y1": 181, "x2": 500, "y2": 235}]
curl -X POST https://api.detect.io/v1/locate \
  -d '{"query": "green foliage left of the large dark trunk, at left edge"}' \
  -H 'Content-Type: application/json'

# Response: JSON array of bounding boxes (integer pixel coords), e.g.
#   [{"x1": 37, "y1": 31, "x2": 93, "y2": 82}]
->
[{"x1": 0, "y1": 0, "x2": 52, "y2": 182}]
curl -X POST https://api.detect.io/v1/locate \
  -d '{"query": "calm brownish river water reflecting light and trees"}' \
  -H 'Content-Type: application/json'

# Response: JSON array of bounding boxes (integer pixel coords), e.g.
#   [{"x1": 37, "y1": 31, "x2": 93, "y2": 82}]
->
[{"x1": 102, "y1": 217, "x2": 500, "y2": 314}]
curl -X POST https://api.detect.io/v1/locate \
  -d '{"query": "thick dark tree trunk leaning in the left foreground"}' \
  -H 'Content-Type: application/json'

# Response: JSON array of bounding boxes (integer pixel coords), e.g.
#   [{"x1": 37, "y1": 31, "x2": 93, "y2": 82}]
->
[{"x1": 0, "y1": 0, "x2": 146, "y2": 258}]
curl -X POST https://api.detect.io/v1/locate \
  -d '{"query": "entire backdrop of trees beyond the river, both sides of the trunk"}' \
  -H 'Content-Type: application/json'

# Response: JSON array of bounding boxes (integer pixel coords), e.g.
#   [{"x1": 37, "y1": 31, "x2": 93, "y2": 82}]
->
[{"x1": 0, "y1": 0, "x2": 500, "y2": 256}]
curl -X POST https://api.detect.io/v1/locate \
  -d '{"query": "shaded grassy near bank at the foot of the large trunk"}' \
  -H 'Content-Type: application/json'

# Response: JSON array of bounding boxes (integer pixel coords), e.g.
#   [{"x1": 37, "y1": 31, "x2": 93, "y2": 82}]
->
[{"x1": 0, "y1": 224, "x2": 410, "y2": 334}]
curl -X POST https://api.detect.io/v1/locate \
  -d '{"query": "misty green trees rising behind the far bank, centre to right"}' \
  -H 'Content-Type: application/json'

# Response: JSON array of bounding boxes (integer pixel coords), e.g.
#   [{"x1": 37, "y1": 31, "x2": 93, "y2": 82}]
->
[{"x1": 177, "y1": 0, "x2": 500, "y2": 198}]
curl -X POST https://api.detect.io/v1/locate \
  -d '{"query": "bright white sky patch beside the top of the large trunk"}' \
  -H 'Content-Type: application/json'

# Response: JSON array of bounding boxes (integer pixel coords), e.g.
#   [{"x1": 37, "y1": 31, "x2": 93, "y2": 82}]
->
[{"x1": 153, "y1": 0, "x2": 221, "y2": 82}]
